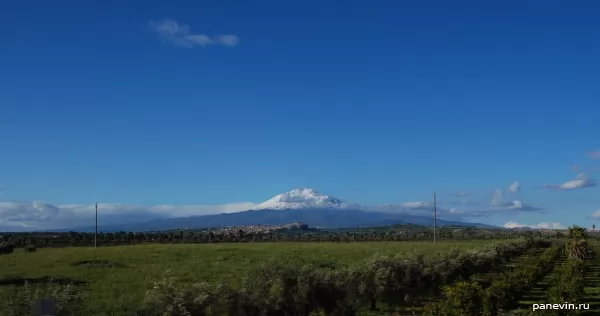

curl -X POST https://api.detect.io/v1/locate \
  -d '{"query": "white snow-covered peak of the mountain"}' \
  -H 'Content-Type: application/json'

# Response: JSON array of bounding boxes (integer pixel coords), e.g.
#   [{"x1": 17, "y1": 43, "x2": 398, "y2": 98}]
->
[{"x1": 253, "y1": 188, "x2": 350, "y2": 210}]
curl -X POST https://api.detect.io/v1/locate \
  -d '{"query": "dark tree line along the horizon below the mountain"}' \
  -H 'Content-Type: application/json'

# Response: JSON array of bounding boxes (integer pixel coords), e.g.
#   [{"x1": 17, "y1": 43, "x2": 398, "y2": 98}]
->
[{"x1": 0, "y1": 228, "x2": 561, "y2": 248}]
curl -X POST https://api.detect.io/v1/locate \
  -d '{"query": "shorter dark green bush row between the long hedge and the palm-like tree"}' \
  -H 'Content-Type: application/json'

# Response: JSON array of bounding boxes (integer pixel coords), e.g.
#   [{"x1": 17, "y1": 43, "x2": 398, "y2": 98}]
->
[{"x1": 423, "y1": 245, "x2": 564, "y2": 316}]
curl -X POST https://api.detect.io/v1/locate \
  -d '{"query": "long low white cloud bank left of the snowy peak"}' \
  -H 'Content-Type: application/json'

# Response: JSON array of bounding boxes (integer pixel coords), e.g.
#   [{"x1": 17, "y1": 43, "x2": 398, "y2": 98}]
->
[{"x1": 0, "y1": 202, "x2": 256, "y2": 229}]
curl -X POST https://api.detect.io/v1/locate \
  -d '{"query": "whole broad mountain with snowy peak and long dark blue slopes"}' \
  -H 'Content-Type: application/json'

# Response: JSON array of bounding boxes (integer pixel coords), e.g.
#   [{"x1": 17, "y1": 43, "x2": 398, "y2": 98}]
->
[{"x1": 54, "y1": 189, "x2": 498, "y2": 232}]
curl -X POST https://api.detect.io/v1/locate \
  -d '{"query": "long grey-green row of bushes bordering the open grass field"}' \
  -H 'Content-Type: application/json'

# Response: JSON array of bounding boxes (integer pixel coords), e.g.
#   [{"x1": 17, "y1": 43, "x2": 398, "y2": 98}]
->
[{"x1": 140, "y1": 239, "x2": 550, "y2": 316}]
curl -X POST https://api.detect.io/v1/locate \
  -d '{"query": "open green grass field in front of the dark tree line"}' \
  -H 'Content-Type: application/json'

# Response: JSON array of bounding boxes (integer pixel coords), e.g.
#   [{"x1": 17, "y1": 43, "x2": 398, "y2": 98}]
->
[{"x1": 0, "y1": 240, "x2": 491, "y2": 315}]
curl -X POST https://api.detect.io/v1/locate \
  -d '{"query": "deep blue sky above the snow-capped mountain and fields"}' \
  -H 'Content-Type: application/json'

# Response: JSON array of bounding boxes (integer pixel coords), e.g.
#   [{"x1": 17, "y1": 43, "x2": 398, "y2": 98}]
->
[{"x1": 0, "y1": 0, "x2": 600, "y2": 228}]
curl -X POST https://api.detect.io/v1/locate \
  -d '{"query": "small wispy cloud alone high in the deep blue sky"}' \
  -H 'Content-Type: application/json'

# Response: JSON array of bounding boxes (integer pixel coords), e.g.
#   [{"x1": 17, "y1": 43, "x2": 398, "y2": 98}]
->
[{"x1": 150, "y1": 19, "x2": 239, "y2": 48}]
